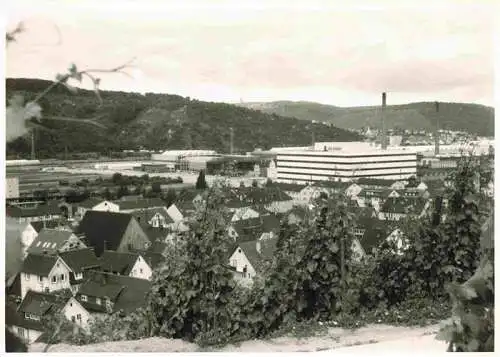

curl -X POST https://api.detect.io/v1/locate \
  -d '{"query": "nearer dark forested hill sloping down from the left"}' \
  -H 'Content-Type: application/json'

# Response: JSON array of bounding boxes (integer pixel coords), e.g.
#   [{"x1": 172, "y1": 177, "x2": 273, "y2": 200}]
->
[{"x1": 6, "y1": 78, "x2": 360, "y2": 158}]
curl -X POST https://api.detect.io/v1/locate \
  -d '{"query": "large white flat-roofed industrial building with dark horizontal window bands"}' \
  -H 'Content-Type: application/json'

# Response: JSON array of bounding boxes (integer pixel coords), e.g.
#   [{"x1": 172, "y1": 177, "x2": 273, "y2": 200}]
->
[{"x1": 276, "y1": 142, "x2": 417, "y2": 184}]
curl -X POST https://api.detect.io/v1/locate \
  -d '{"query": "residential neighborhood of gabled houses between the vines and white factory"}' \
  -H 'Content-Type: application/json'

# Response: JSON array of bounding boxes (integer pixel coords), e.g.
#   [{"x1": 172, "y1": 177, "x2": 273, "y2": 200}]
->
[{"x1": 7, "y1": 171, "x2": 458, "y2": 342}]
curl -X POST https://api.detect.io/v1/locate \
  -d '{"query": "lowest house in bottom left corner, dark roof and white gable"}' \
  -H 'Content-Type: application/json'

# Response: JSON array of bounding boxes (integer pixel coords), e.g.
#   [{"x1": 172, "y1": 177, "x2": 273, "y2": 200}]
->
[{"x1": 5, "y1": 290, "x2": 90, "y2": 344}]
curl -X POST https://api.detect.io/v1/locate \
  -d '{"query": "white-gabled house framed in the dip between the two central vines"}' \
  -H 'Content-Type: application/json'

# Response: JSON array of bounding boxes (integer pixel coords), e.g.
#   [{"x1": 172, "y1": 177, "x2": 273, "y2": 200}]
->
[{"x1": 229, "y1": 238, "x2": 277, "y2": 285}]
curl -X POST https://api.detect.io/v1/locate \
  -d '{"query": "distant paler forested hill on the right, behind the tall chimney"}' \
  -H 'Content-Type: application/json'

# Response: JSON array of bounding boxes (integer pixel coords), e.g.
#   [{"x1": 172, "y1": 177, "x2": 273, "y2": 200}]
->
[{"x1": 239, "y1": 101, "x2": 495, "y2": 136}]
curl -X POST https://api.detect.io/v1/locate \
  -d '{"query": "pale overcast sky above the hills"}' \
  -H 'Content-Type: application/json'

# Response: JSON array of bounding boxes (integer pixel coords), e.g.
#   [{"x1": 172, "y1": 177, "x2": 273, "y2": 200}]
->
[{"x1": 6, "y1": 0, "x2": 495, "y2": 106}]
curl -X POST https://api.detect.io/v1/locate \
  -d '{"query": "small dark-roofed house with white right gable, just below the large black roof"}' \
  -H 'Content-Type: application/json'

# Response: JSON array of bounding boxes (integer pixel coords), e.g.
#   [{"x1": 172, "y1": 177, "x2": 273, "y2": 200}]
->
[{"x1": 99, "y1": 250, "x2": 153, "y2": 280}]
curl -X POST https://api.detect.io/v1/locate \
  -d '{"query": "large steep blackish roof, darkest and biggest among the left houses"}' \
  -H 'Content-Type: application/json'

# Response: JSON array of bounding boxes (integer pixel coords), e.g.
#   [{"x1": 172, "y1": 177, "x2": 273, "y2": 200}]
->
[{"x1": 77, "y1": 211, "x2": 133, "y2": 256}]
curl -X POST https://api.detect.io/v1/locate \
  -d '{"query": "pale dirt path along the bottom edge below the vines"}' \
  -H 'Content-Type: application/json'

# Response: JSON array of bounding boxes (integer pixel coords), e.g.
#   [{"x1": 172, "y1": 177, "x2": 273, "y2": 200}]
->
[{"x1": 30, "y1": 325, "x2": 446, "y2": 352}]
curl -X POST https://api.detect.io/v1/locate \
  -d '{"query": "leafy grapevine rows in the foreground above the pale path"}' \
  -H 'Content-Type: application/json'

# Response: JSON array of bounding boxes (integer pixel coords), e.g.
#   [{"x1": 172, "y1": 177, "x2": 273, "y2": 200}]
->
[{"x1": 38, "y1": 158, "x2": 494, "y2": 351}]
